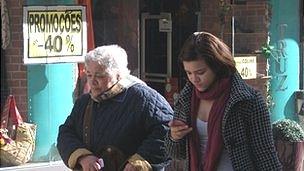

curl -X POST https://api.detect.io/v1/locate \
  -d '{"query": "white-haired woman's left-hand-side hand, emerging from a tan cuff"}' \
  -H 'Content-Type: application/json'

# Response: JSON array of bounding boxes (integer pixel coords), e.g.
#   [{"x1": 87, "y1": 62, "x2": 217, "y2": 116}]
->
[{"x1": 79, "y1": 155, "x2": 102, "y2": 171}]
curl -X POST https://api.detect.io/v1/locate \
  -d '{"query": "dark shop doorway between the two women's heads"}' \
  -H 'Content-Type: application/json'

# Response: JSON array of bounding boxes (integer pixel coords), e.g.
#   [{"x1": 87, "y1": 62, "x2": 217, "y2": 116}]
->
[{"x1": 138, "y1": 2, "x2": 200, "y2": 104}]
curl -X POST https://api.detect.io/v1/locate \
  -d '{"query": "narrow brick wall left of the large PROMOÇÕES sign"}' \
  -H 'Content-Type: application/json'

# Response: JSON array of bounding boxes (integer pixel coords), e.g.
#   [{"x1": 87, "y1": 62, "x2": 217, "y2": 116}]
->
[{"x1": 1, "y1": 0, "x2": 27, "y2": 119}]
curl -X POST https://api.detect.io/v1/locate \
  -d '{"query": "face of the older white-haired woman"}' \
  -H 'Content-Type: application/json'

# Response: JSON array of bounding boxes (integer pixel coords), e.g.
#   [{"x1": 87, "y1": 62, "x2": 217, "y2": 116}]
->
[{"x1": 86, "y1": 61, "x2": 118, "y2": 97}]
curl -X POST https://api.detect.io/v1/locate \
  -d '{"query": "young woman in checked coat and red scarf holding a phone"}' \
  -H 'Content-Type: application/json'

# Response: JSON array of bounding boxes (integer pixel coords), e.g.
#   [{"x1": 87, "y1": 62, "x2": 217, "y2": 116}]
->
[{"x1": 165, "y1": 32, "x2": 281, "y2": 171}]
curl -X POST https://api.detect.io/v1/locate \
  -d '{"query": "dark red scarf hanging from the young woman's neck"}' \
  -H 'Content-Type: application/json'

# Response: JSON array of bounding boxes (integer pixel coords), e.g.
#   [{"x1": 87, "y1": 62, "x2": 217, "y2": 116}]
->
[{"x1": 190, "y1": 77, "x2": 231, "y2": 171}]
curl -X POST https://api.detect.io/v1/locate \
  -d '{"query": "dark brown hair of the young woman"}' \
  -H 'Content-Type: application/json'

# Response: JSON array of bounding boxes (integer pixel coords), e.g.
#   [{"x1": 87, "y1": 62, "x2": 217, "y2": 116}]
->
[{"x1": 179, "y1": 32, "x2": 236, "y2": 78}]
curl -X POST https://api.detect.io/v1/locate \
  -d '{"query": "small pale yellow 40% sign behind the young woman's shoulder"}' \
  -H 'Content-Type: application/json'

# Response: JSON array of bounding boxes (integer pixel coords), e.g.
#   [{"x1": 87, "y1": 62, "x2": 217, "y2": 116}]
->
[{"x1": 234, "y1": 56, "x2": 257, "y2": 79}]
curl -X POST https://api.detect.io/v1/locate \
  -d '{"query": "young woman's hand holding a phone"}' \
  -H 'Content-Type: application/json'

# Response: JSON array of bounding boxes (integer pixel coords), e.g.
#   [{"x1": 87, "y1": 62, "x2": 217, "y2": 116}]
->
[{"x1": 169, "y1": 119, "x2": 192, "y2": 141}]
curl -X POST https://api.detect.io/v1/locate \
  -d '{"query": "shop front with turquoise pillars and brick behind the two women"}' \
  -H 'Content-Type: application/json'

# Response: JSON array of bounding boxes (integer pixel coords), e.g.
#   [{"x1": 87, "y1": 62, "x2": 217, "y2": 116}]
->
[{"x1": 0, "y1": 0, "x2": 304, "y2": 170}]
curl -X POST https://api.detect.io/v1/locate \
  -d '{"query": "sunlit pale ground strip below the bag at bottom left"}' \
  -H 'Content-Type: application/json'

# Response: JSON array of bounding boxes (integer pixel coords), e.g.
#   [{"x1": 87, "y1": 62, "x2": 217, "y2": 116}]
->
[{"x1": 0, "y1": 161, "x2": 71, "y2": 171}]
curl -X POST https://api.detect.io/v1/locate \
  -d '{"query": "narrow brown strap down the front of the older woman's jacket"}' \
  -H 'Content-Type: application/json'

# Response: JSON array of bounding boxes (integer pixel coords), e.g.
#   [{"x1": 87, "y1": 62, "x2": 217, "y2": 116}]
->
[{"x1": 83, "y1": 99, "x2": 93, "y2": 145}]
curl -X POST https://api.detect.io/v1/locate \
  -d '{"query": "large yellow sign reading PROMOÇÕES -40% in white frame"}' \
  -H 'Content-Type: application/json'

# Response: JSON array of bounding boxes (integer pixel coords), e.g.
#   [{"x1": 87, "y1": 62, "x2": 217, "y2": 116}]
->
[{"x1": 23, "y1": 6, "x2": 87, "y2": 64}]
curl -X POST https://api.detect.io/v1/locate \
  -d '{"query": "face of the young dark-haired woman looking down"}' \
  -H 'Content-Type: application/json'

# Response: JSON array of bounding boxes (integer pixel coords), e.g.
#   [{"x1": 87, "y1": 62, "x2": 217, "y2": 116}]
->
[{"x1": 183, "y1": 59, "x2": 216, "y2": 92}]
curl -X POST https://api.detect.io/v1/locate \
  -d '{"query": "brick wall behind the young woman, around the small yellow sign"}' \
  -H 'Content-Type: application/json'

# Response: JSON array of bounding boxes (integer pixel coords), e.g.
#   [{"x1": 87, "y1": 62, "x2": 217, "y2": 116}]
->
[{"x1": 201, "y1": 0, "x2": 270, "y2": 96}]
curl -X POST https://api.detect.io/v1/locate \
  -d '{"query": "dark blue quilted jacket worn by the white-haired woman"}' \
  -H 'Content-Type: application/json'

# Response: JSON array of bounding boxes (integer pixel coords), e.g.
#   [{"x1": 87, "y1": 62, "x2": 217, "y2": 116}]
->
[{"x1": 57, "y1": 84, "x2": 173, "y2": 168}]
